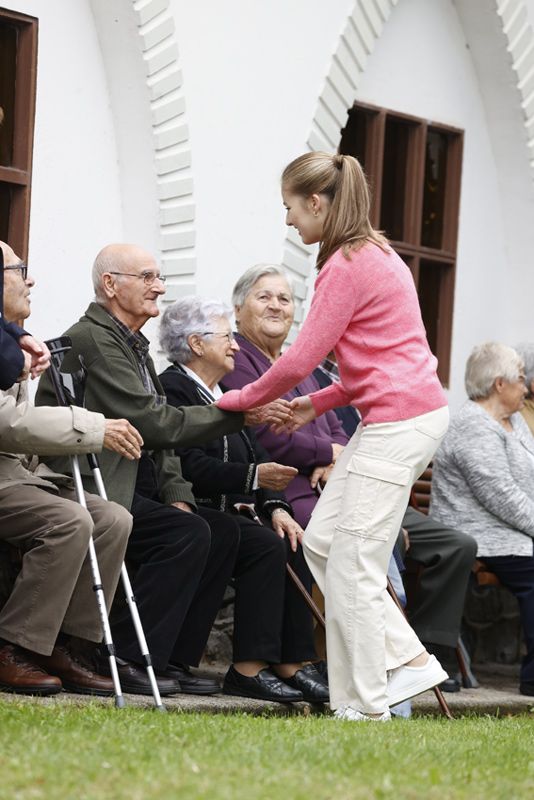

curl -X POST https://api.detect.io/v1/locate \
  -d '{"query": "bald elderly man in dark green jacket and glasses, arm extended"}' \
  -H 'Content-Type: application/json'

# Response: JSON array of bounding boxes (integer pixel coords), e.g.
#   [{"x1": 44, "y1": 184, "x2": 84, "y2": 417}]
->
[{"x1": 37, "y1": 244, "x2": 288, "y2": 694}]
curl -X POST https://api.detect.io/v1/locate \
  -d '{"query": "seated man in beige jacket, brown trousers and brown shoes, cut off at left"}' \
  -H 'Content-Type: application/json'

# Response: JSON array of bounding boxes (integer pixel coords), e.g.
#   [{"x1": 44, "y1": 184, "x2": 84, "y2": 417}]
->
[{"x1": 0, "y1": 242, "x2": 141, "y2": 695}]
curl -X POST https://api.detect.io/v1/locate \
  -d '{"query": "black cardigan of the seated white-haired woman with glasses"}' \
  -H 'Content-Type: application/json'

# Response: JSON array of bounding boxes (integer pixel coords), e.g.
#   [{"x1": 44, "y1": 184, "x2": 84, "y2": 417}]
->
[{"x1": 159, "y1": 365, "x2": 292, "y2": 517}]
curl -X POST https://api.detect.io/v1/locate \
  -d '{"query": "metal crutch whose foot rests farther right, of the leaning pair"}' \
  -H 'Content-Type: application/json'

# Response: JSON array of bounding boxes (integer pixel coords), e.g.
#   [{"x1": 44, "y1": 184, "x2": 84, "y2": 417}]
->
[{"x1": 47, "y1": 336, "x2": 167, "y2": 712}]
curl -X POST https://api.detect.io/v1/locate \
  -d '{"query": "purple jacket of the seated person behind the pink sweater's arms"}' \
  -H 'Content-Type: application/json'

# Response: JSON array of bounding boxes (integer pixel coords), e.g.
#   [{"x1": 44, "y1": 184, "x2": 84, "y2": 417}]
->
[{"x1": 222, "y1": 334, "x2": 348, "y2": 527}]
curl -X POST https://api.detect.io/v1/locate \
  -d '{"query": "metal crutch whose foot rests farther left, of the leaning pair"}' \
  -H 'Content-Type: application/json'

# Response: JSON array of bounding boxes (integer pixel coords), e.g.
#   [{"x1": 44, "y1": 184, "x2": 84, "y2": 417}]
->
[{"x1": 46, "y1": 339, "x2": 126, "y2": 708}]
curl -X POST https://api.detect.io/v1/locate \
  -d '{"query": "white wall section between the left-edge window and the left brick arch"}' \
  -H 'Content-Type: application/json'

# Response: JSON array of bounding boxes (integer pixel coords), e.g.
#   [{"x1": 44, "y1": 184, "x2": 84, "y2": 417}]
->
[{"x1": 3, "y1": 0, "x2": 122, "y2": 338}]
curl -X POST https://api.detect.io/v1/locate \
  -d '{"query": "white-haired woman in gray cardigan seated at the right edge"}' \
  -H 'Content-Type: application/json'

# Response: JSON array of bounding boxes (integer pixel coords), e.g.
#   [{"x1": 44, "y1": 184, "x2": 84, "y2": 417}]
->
[{"x1": 430, "y1": 342, "x2": 534, "y2": 695}]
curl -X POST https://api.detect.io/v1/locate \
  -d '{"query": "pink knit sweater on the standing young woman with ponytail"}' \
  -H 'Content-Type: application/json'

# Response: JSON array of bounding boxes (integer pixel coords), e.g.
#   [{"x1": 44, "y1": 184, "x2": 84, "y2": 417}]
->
[{"x1": 217, "y1": 243, "x2": 447, "y2": 424}]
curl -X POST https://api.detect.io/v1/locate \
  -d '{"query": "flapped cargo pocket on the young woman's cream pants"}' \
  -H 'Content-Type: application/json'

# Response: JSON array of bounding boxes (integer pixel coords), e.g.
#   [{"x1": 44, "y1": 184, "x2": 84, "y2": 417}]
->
[{"x1": 335, "y1": 453, "x2": 412, "y2": 541}]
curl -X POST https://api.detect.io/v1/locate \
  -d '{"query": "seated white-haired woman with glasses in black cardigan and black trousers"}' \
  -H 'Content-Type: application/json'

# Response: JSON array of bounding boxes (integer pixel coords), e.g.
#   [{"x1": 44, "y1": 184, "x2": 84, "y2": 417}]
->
[{"x1": 160, "y1": 296, "x2": 328, "y2": 702}]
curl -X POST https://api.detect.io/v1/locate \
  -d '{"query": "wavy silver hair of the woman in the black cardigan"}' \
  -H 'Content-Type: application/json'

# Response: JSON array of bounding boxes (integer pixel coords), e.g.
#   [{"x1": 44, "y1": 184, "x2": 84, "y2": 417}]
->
[{"x1": 159, "y1": 294, "x2": 232, "y2": 364}]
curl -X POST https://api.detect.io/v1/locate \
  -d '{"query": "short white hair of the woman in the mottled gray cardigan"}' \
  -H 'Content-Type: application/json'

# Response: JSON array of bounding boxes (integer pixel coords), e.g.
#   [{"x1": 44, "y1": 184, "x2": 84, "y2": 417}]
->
[{"x1": 465, "y1": 342, "x2": 523, "y2": 400}]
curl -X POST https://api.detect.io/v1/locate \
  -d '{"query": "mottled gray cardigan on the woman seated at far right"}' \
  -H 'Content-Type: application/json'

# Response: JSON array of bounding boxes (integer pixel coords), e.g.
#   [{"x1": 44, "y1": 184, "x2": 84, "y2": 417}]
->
[{"x1": 430, "y1": 400, "x2": 534, "y2": 558}]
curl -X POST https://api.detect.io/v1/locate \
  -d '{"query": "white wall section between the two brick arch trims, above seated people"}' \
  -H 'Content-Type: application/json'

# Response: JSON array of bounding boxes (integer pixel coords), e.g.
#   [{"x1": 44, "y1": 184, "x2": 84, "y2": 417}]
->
[{"x1": 172, "y1": 0, "x2": 352, "y2": 296}]
